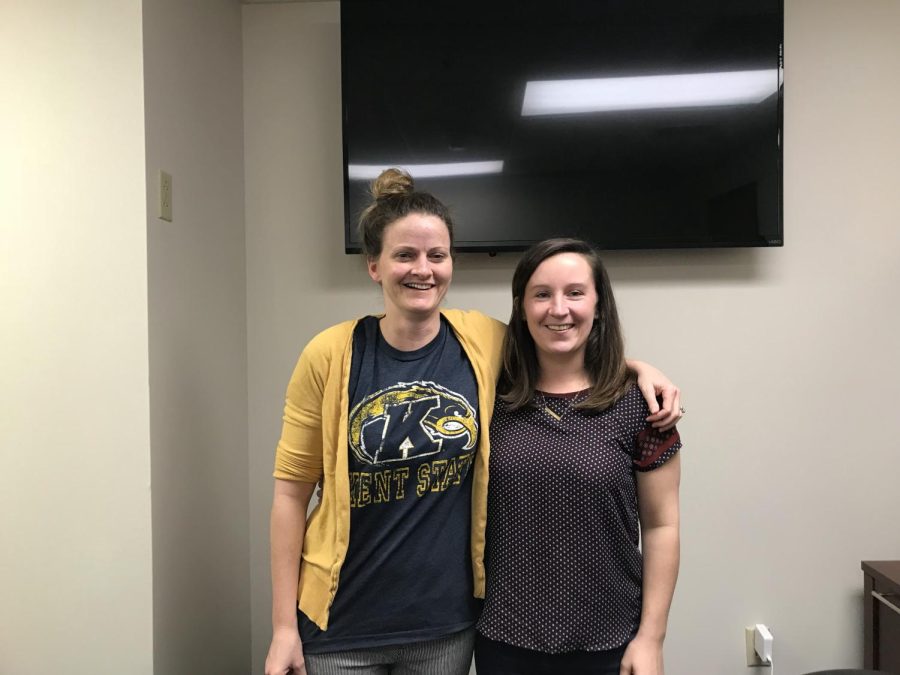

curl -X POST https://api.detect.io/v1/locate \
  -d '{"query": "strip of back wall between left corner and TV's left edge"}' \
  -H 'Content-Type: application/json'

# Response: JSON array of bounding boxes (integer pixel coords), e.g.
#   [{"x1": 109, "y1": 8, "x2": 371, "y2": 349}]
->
[{"x1": 244, "y1": 2, "x2": 358, "y2": 672}]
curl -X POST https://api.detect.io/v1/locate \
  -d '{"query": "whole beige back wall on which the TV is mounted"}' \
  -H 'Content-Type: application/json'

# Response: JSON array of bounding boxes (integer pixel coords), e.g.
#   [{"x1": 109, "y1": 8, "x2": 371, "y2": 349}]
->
[{"x1": 244, "y1": 0, "x2": 900, "y2": 675}]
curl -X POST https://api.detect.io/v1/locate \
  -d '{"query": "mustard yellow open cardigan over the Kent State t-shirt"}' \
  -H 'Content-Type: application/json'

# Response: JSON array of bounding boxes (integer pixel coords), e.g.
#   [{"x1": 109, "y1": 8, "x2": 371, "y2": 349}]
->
[{"x1": 274, "y1": 309, "x2": 505, "y2": 630}]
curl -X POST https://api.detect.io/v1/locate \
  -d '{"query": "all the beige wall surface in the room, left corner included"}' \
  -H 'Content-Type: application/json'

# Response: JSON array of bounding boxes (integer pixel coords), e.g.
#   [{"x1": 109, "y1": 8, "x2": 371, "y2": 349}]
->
[{"x1": 0, "y1": 0, "x2": 900, "y2": 675}]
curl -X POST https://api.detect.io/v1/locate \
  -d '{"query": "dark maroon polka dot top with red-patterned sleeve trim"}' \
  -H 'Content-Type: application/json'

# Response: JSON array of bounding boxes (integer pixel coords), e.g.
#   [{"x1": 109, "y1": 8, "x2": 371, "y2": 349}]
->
[{"x1": 478, "y1": 386, "x2": 681, "y2": 654}]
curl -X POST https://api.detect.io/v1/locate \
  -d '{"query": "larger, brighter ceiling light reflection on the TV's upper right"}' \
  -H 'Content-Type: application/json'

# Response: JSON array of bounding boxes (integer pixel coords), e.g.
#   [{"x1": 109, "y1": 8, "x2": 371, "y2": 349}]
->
[{"x1": 522, "y1": 68, "x2": 778, "y2": 117}]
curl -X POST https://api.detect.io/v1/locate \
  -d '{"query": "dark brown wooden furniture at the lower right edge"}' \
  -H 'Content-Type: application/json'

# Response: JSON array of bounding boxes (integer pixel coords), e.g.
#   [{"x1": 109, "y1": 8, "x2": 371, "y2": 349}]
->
[{"x1": 862, "y1": 560, "x2": 900, "y2": 675}]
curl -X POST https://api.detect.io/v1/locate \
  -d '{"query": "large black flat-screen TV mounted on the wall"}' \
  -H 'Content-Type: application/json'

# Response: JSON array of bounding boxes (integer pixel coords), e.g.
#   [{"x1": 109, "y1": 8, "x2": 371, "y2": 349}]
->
[{"x1": 341, "y1": 0, "x2": 783, "y2": 252}]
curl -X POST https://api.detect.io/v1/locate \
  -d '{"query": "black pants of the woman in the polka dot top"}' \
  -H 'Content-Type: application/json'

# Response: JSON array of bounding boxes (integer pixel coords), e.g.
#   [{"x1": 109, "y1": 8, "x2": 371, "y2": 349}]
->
[{"x1": 475, "y1": 633, "x2": 625, "y2": 675}]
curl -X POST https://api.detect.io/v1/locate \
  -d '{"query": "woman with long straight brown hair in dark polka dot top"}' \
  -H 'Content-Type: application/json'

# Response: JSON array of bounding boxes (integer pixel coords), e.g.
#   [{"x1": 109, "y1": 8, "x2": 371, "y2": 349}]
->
[{"x1": 475, "y1": 239, "x2": 681, "y2": 675}]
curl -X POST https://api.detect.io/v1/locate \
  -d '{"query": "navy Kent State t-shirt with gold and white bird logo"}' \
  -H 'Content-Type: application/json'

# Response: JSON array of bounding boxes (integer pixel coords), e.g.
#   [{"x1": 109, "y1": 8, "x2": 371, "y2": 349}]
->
[{"x1": 300, "y1": 317, "x2": 478, "y2": 654}]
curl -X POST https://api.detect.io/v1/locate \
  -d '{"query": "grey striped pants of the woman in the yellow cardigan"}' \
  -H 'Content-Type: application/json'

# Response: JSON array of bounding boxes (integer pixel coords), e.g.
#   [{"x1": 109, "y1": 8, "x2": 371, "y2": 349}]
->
[{"x1": 304, "y1": 628, "x2": 475, "y2": 675}]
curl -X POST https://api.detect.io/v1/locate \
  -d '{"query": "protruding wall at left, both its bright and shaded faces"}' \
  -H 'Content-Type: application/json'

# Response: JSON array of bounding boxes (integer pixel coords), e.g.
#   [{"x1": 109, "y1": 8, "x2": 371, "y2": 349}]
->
[{"x1": 0, "y1": 0, "x2": 250, "y2": 675}]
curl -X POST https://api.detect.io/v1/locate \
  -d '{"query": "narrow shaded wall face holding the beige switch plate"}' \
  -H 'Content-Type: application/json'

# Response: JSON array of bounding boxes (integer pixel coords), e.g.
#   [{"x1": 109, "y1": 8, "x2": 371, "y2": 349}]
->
[{"x1": 143, "y1": 0, "x2": 250, "y2": 675}]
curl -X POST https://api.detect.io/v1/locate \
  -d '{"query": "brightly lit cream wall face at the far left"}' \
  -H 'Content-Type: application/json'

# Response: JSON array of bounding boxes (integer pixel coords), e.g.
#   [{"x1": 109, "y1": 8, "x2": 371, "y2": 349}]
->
[{"x1": 0, "y1": 0, "x2": 153, "y2": 675}]
